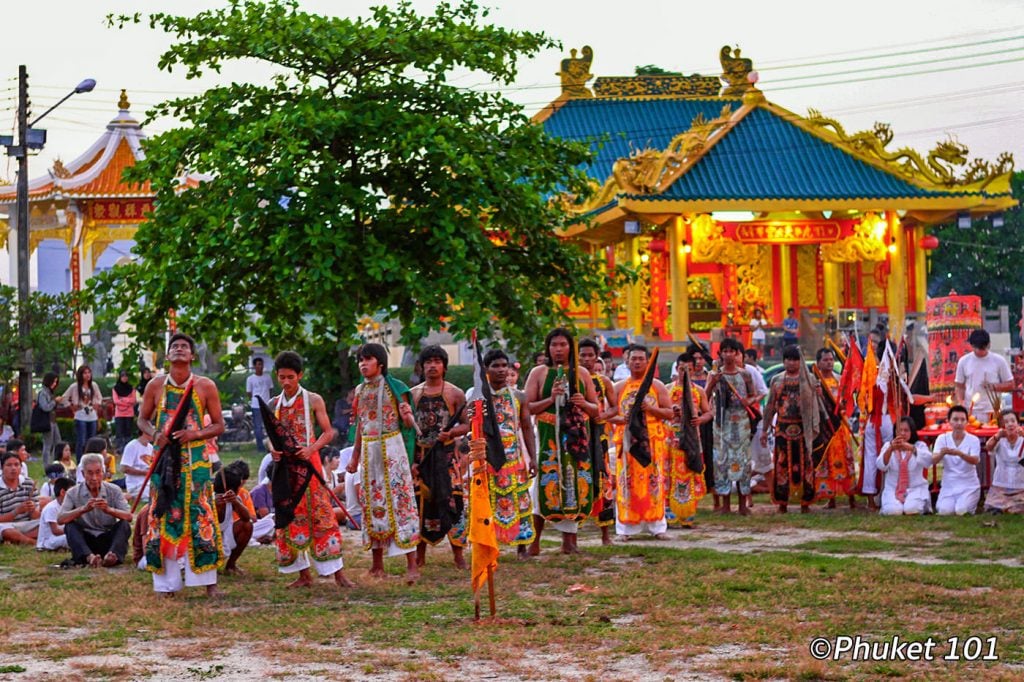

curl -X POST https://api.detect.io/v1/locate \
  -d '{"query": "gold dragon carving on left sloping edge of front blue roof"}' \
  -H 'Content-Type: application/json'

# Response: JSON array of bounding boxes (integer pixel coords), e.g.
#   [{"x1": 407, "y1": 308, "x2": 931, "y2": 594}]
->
[{"x1": 598, "y1": 104, "x2": 731, "y2": 193}]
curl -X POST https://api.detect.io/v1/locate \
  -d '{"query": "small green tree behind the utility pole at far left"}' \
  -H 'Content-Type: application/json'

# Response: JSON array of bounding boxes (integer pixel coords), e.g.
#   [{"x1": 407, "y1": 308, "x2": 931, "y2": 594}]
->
[{"x1": 0, "y1": 285, "x2": 75, "y2": 384}]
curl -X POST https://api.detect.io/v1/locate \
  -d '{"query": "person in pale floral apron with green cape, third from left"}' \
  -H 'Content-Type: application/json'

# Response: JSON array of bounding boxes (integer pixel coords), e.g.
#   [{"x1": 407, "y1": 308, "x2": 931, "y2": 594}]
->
[{"x1": 346, "y1": 343, "x2": 420, "y2": 584}]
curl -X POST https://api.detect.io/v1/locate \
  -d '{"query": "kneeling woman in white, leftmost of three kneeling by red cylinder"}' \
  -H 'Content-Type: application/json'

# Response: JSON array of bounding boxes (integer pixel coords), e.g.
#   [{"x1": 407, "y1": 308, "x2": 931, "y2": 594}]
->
[{"x1": 878, "y1": 417, "x2": 932, "y2": 515}]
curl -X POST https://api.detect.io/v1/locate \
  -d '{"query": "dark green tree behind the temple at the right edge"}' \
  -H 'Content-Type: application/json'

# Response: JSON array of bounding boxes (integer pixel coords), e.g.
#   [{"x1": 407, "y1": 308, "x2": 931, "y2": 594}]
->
[{"x1": 928, "y1": 172, "x2": 1024, "y2": 332}]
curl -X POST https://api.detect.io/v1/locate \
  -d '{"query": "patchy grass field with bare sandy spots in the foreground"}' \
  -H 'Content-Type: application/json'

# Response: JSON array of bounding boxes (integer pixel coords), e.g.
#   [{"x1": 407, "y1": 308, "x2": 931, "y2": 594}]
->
[{"x1": 0, "y1": 446, "x2": 1024, "y2": 681}]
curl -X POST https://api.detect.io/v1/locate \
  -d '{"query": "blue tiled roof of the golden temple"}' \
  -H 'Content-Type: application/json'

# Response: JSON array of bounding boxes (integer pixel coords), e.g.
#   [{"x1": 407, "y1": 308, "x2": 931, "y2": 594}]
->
[{"x1": 544, "y1": 99, "x2": 987, "y2": 201}]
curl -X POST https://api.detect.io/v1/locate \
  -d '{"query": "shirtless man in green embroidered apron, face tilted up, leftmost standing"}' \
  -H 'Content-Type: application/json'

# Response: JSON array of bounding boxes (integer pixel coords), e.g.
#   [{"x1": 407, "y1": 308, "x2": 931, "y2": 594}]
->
[{"x1": 138, "y1": 333, "x2": 224, "y2": 596}]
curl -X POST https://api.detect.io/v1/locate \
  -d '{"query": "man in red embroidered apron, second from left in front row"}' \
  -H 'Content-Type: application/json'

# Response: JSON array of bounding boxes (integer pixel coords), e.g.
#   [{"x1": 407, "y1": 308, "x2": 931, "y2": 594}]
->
[{"x1": 270, "y1": 350, "x2": 354, "y2": 587}]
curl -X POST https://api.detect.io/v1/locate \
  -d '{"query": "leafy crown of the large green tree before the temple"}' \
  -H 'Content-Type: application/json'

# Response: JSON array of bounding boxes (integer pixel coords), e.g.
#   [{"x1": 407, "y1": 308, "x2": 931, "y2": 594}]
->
[{"x1": 92, "y1": 0, "x2": 622, "y2": 382}]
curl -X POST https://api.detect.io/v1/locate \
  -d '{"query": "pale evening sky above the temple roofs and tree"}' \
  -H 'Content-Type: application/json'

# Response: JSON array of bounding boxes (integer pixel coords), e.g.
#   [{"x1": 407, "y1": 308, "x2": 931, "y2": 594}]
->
[{"x1": 0, "y1": 0, "x2": 1024, "y2": 180}]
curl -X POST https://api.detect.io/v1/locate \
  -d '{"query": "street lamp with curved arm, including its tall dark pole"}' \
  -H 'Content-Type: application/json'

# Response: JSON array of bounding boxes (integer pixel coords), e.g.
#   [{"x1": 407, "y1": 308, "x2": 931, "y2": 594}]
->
[{"x1": 0, "y1": 65, "x2": 96, "y2": 433}]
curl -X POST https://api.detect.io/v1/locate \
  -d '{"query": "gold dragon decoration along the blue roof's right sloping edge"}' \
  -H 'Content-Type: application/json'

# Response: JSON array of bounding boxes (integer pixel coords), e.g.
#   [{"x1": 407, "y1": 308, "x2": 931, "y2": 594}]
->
[{"x1": 805, "y1": 109, "x2": 1014, "y2": 191}]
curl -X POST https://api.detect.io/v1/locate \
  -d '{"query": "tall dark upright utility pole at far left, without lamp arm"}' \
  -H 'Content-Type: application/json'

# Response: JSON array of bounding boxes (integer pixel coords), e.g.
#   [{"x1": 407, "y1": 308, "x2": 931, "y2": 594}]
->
[{"x1": 17, "y1": 65, "x2": 32, "y2": 435}]
